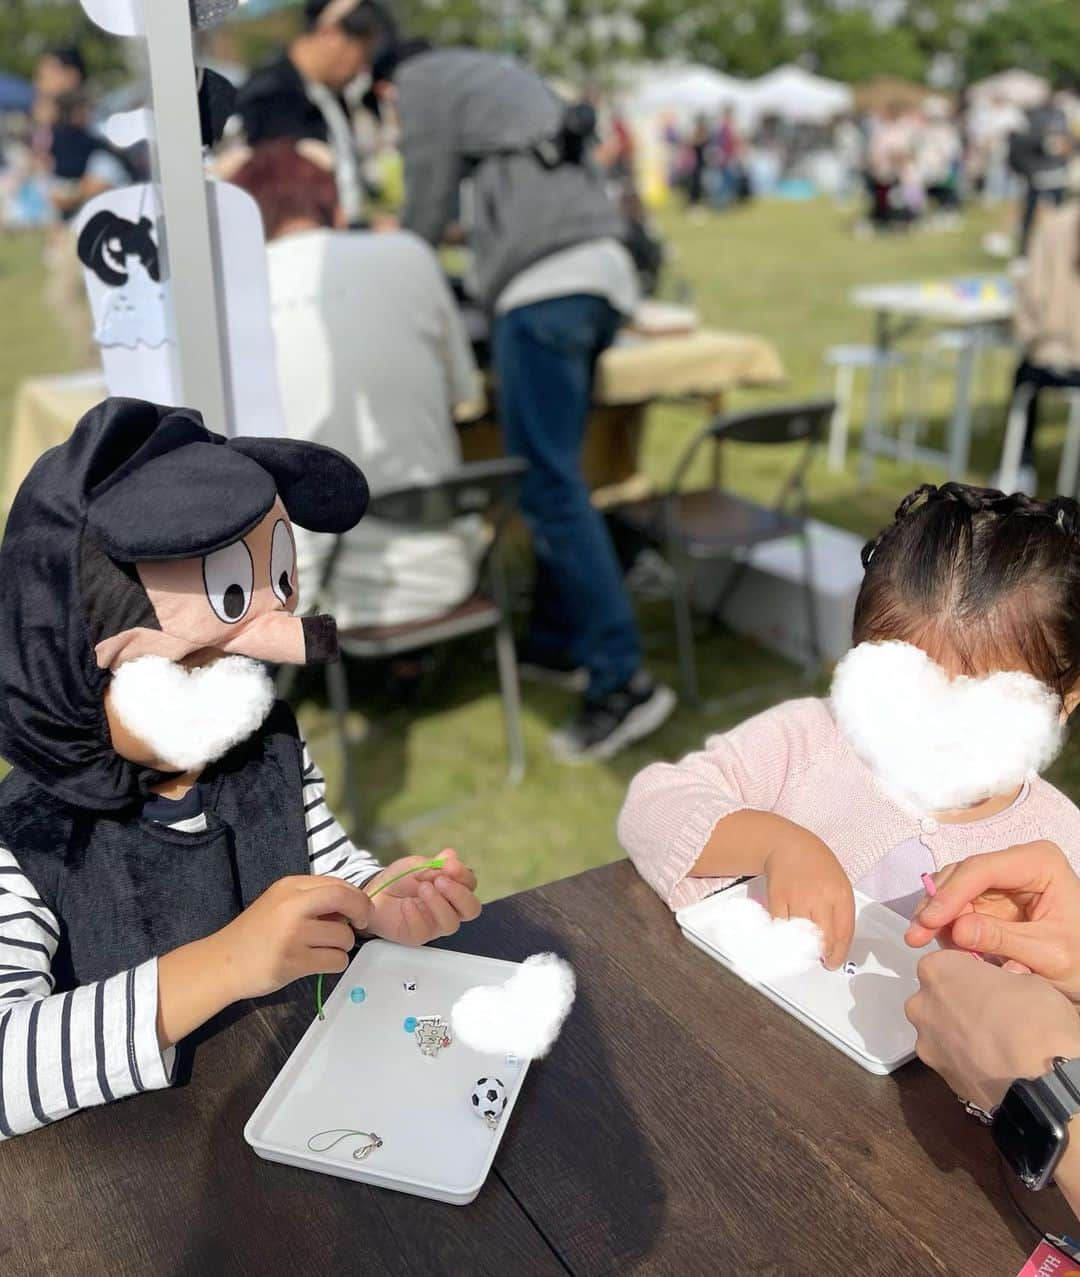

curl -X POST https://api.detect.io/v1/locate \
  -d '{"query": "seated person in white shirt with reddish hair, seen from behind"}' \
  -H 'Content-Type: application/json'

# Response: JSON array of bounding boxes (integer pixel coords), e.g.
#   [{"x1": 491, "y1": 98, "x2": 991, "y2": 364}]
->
[{"x1": 232, "y1": 140, "x2": 484, "y2": 628}]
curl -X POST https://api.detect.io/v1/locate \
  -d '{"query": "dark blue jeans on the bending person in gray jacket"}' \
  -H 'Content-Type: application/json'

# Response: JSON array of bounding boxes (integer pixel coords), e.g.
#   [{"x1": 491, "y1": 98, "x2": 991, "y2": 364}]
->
[{"x1": 493, "y1": 295, "x2": 641, "y2": 700}]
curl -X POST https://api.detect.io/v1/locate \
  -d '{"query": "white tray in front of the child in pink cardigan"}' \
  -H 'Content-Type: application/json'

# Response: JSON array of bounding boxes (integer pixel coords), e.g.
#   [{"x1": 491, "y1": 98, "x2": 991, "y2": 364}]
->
[{"x1": 675, "y1": 877, "x2": 928, "y2": 1074}]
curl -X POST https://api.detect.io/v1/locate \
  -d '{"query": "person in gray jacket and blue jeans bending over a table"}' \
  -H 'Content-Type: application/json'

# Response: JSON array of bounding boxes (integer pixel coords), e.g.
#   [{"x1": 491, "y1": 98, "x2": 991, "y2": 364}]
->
[{"x1": 373, "y1": 47, "x2": 675, "y2": 761}]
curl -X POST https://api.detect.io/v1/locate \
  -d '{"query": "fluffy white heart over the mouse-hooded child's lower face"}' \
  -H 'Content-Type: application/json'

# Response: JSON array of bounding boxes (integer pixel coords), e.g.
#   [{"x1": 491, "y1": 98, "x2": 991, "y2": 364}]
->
[{"x1": 110, "y1": 656, "x2": 274, "y2": 771}]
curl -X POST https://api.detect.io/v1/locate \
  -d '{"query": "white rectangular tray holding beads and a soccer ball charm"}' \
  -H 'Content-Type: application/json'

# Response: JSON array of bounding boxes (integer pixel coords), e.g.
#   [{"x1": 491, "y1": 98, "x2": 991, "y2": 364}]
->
[{"x1": 244, "y1": 940, "x2": 529, "y2": 1205}]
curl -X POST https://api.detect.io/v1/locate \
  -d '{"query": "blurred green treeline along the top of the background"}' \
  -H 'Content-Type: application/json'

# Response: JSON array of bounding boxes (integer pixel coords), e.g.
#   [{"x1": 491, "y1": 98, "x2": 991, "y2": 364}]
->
[{"x1": 8, "y1": 0, "x2": 1080, "y2": 86}]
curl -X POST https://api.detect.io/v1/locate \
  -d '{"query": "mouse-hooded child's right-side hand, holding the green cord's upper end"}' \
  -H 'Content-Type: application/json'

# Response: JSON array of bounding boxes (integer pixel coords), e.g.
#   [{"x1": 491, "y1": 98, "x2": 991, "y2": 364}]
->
[{"x1": 364, "y1": 850, "x2": 480, "y2": 945}]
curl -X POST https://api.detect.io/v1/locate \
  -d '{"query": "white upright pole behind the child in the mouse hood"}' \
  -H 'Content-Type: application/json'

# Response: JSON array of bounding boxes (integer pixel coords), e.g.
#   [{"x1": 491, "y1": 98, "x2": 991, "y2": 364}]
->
[{"x1": 143, "y1": 0, "x2": 235, "y2": 434}]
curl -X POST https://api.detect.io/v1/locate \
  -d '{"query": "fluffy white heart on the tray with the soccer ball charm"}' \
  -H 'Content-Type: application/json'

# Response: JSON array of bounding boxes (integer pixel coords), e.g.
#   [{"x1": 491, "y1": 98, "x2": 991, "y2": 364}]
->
[{"x1": 451, "y1": 954, "x2": 576, "y2": 1060}]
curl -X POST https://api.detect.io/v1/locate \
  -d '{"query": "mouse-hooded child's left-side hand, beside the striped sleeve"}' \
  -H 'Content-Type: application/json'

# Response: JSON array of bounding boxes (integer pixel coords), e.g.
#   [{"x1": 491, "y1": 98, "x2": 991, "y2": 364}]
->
[{"x1": 209, "y1": 873, "x2": 373, "y2": 1001}]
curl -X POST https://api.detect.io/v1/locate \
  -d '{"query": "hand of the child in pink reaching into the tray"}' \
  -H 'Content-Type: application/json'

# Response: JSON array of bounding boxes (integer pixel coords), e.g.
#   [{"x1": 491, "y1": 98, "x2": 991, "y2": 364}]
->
[{"x1": 765, "y1": 829, "x2": 855, "y2": 969}]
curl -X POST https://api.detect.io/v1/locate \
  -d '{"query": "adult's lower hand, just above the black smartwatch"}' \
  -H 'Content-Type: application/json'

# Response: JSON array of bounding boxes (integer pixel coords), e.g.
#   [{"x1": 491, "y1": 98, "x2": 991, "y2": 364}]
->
[{"x1": 905, "y1": 950, "x2": 1080, "y2": 1108}]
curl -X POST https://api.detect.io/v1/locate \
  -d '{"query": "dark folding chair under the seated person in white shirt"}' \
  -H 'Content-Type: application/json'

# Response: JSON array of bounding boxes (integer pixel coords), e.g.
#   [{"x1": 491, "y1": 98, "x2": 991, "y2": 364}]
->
[{"x1": 310, "y1": 458, "x2": 525, "y2": 835}]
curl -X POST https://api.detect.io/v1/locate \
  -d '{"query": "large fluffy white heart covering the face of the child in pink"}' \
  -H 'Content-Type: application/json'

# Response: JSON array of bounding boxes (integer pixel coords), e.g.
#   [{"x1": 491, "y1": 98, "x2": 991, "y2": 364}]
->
[{"x1": 832, "y1": 642, "x2": 1065, "y2": 813}]
